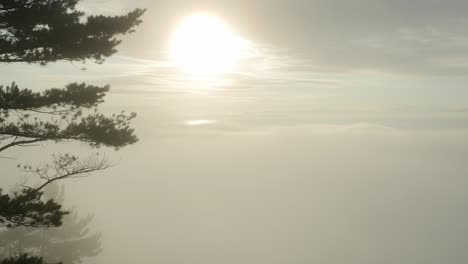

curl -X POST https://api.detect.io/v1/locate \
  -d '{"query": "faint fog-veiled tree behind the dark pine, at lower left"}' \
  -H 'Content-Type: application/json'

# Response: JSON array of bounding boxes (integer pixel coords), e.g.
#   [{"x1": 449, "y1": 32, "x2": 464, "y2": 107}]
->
[{"x1": 0, "y1": 184, "x2": 101, "y2": 264}]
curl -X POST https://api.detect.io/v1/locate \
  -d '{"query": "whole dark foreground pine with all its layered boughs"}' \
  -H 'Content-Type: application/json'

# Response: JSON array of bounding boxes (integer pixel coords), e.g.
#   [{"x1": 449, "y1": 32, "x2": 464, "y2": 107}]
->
[{"x1": 0, "y1": 0, "x2": 144, "y2": 264}]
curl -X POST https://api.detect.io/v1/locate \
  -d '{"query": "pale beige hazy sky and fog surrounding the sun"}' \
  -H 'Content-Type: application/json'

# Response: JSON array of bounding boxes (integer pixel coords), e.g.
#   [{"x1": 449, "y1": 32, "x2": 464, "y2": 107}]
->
[{"x1": 0, "y1": 0, "x2": 468, "y2": 264}]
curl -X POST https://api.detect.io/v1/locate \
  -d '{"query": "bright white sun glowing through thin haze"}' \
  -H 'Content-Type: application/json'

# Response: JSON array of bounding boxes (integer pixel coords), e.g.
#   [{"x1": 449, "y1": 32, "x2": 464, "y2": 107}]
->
[{"x1": 170, "y1": 14, "x2": 249, "y2": 75}]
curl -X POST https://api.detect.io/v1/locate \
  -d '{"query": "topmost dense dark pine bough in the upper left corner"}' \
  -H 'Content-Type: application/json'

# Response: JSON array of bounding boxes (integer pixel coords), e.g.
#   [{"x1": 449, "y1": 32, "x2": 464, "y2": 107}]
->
[{"x1": 0, "y1": 0, "x2": 144, "y2": 64}]
